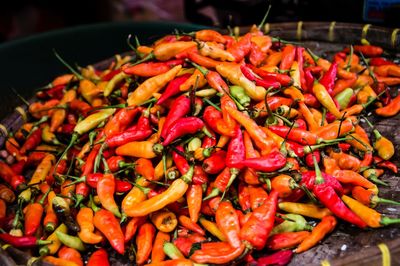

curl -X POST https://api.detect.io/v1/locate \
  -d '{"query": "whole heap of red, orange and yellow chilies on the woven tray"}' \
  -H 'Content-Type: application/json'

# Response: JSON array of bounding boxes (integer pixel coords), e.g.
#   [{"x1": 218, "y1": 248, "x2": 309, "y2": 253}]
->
[{"x1": 0, "y1": 23, "x2": 400, "y2": 265}]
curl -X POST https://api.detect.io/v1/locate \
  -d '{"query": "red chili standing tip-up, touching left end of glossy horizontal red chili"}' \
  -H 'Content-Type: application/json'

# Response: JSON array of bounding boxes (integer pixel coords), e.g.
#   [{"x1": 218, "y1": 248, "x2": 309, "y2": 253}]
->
[{"x1": 225, "y1": 126, "x2": 245, "y2": 169}]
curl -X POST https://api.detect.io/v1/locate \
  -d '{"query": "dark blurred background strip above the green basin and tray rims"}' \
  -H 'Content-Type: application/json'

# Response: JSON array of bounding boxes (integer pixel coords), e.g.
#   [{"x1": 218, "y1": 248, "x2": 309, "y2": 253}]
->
[{"x1": 0, "y1": 0, "x2": 400, "y2": 43}]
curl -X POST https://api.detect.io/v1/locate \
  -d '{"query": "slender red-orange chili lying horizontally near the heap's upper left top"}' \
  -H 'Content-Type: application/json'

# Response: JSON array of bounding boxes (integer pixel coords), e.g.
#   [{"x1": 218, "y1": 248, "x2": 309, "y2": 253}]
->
[{"x1": 122, "y1": 59, "x2": 184, "y2": 77}]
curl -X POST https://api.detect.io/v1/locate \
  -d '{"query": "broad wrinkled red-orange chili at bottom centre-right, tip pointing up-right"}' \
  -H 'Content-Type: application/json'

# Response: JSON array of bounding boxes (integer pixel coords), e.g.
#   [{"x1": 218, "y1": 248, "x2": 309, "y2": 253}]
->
[{"x1": 240, "y1": 190, "x2": 278, "y2": 250}]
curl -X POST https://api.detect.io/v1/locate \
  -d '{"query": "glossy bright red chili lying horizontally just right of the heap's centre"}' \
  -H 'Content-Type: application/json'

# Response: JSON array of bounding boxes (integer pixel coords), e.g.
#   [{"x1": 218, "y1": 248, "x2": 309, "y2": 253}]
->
[{"x1": 238, "y1": 151, "x2": 286, "y2": 172}]
